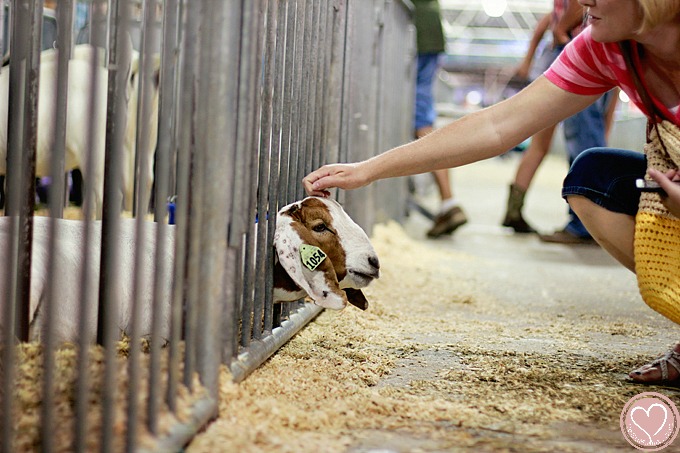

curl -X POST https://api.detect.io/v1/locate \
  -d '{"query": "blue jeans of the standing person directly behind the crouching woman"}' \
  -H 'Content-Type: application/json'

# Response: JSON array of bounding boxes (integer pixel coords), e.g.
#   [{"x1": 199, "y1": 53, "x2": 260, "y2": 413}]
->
[{"x1": 562, "y1": 91, "x2": 612, "y2": 237}]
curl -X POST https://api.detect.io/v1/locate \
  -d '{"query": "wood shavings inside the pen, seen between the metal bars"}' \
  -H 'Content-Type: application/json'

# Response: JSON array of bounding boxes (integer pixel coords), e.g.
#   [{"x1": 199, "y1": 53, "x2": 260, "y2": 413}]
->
[{"x1": 0, "y1": 339, "x2": 206, "y2": 452}]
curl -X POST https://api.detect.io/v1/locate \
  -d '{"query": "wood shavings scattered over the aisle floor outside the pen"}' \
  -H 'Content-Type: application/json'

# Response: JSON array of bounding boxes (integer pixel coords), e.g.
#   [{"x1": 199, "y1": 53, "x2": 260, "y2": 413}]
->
[{"x1": 187, "y1": 223, "x2": 680, "y2": 453}]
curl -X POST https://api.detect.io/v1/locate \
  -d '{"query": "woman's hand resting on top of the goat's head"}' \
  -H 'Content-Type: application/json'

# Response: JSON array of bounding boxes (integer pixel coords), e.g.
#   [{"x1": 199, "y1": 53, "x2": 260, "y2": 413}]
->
[{"x1": 302, "y1": 162, "x2": 371, "y2": 197}]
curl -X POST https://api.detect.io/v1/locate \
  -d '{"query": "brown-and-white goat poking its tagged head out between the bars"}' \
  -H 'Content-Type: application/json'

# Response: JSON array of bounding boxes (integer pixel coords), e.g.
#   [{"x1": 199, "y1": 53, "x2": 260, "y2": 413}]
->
[{"x1": 0, "y1": 197, "x2": 380, "y2": 342}]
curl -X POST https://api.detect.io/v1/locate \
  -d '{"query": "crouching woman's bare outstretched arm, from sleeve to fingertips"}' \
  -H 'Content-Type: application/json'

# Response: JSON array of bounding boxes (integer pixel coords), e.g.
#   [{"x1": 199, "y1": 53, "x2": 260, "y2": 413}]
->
[{"x1": 302, "y1": 76, "x2": 600, "y2": 197}]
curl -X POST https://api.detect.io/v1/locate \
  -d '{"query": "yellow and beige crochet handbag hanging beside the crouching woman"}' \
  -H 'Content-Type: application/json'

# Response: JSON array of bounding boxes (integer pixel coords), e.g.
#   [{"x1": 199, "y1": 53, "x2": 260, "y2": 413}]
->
[{"x1": 634, "y1": 121, "x2": 680, "y2": 324}]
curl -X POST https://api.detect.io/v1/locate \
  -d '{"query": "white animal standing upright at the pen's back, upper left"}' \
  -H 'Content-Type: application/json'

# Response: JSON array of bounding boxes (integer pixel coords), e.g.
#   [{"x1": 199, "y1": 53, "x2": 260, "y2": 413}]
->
[{"x1": 0, "y1": 44, "x2": 158, "y2": 218}]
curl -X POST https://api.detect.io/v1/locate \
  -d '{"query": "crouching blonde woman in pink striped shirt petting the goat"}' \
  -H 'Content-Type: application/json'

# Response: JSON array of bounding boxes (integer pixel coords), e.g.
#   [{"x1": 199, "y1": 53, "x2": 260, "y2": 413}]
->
[{"x1": 302, "y1": 0, "x2": 680, "y2": 385}]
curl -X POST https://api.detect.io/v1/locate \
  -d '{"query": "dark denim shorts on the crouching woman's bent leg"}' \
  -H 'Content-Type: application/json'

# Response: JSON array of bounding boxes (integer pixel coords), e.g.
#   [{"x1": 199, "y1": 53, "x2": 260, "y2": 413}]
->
[{"x1": 562, "y1": 148, "x2": 647, "y2": 216}]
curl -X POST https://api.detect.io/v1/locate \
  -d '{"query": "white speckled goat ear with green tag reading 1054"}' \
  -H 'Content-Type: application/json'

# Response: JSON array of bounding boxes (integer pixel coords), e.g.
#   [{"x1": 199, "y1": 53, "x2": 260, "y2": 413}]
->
[{"x1": 274, "y1": 214, "x2": 347, "y2": 310}]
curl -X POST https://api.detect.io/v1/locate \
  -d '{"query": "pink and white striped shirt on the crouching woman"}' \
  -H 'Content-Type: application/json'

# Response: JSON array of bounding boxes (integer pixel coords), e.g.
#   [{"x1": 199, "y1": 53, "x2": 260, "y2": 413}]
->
[{"x1": 544, "y1": 27, "x2": 680, "y2": 125}]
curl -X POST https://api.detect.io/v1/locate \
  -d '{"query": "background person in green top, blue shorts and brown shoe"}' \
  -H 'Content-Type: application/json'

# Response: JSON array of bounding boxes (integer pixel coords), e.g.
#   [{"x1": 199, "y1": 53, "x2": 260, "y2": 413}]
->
[{"x1": 413, "y1": 0, "x2": 467, "y2": 238}]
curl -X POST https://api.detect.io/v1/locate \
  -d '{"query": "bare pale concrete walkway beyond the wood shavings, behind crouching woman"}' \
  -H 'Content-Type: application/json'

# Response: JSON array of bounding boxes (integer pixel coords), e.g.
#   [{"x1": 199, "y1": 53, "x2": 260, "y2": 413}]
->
[{"x1": 405, "y1": 153, "x2": 680, "y2": 332}]
